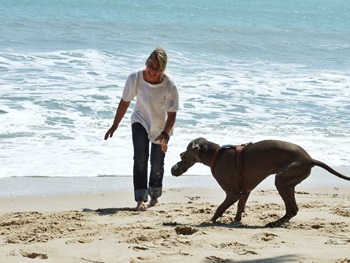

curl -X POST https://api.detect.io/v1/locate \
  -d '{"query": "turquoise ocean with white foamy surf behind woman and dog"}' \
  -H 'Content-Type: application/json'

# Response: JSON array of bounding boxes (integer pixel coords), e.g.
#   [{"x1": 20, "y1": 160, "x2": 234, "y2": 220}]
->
[{"x1": 0, "y1": 0, "x2": 350, "y2": 196}]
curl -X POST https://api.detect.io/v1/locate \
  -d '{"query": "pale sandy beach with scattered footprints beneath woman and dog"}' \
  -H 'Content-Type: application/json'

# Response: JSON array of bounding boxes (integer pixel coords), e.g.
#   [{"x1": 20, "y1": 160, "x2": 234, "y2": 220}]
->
[{"x1": 0, "y1": 186, "x2": 350, "y2": 263}]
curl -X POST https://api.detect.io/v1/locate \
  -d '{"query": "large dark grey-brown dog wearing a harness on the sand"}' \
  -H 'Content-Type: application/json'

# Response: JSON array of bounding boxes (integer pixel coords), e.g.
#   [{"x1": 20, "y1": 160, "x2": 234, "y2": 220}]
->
[{"x1": 171, "y1": 138, "x2": 350, "y2": 227}]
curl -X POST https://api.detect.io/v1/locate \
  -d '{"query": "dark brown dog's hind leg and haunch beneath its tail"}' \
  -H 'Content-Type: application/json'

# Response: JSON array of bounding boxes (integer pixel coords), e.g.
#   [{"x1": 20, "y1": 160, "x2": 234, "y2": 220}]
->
[{"x1": 266, "y1": 165, "x2": 311, "y2": 227}]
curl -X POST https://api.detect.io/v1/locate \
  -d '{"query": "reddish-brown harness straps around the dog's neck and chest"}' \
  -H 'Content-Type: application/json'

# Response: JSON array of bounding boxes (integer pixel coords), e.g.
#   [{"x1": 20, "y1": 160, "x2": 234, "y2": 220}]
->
[{"x1": 210, "y1": 142, "x2": 253, "y2": 194}]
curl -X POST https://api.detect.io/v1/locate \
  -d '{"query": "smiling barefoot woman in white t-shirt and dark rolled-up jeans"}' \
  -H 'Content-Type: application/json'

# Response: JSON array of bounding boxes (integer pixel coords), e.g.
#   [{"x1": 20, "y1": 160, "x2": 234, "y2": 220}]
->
[{"x1": 104, "y1": 47, "x2": 179, "y2": 211}]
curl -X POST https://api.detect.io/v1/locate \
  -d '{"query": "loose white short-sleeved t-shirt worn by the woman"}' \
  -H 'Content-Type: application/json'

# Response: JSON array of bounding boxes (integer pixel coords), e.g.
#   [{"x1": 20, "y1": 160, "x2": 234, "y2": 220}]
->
[{"x1": 122, "y1": 69, "x2": 179, "y2": 144}]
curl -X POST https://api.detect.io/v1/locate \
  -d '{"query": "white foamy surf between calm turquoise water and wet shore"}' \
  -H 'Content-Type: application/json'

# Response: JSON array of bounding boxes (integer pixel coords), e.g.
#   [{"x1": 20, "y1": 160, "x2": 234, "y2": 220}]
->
[{"x1": 0, "y1": 50, "x2": 350, "y2": 182}]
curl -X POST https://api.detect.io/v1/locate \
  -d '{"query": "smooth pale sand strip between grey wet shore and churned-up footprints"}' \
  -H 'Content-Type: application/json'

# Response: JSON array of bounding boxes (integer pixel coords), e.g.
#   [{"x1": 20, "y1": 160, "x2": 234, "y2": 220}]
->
[{"x1": 0, "y1": 184, "x2": 350, "y2": 213}]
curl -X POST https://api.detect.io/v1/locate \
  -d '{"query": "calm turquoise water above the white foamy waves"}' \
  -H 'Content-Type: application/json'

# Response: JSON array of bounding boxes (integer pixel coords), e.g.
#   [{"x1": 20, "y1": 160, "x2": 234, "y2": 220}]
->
[{"x1": 0, "y1": 0, "x2": 350, "y2": 68}]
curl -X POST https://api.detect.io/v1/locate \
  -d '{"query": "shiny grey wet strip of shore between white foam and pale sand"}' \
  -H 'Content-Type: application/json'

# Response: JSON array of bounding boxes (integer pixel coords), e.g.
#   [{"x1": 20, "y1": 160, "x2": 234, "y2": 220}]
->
[{"x1": 0, "y1": 166, "x2": 350, "y2": 198}]
